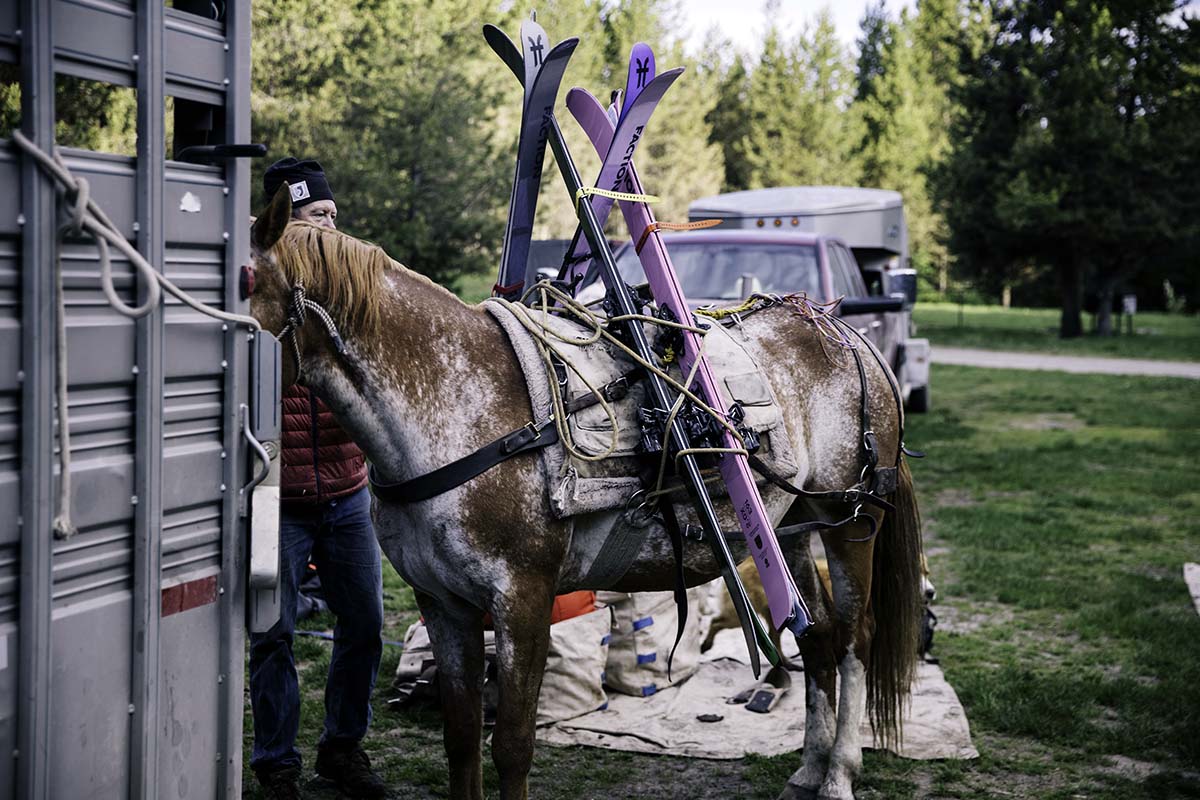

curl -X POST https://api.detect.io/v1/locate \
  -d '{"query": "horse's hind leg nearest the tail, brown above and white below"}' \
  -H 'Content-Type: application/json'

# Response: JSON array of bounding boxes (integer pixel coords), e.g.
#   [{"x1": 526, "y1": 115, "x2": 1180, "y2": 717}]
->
[{"x1": 817, "y1": 523, "x2": 874, "y2": 800}]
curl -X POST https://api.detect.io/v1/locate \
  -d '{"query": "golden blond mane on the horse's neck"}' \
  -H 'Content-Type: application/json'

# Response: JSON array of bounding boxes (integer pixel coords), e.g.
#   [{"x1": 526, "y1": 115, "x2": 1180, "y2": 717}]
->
[{"x1": 274, "y1": 219, "x2": 388, "y2": 332}]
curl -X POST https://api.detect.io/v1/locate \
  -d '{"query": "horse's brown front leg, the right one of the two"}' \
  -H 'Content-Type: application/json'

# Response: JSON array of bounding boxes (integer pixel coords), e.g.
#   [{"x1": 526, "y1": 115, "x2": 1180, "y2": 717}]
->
[{"x1": 491, "y1": 576, "x2": 554, "y2": 800}]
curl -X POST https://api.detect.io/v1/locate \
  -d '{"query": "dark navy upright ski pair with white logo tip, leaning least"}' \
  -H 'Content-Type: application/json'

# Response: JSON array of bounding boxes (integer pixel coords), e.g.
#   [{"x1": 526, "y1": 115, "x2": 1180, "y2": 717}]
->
[{"x1": 493, "y1": 19, "x2": 580, "y2": 299}]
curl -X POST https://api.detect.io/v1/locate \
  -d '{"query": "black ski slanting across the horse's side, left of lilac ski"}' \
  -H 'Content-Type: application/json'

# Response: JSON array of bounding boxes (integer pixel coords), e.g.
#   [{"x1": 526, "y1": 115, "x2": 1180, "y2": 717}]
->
[{"x1": 484, "y1": 25, "x2": 779, "y2": 676}]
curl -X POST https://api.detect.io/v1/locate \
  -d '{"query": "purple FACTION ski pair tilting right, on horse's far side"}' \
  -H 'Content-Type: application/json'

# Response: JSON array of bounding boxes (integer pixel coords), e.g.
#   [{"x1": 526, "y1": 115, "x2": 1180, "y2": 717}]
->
[{"x1": 558, "y1": 53, "x2": 683, "y2": 297}]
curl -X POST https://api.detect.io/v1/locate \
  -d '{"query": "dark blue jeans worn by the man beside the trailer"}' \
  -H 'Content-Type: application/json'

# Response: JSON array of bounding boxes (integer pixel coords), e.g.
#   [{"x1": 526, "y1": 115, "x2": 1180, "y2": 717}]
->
[{"x1": 250, "y1": 487, "x2": 383, "y2": 772}]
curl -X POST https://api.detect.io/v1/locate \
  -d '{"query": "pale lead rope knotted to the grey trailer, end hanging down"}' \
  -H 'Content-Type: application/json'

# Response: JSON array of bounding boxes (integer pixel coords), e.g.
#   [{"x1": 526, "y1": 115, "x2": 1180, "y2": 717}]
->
[{"x1": 12, "y1": 131, "x2": 262, "y2": 539}]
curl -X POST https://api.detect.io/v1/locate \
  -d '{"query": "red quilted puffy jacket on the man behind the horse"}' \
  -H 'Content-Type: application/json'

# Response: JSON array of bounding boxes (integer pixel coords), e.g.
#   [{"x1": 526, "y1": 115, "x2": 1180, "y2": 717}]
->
[{"x1": 280, "y1": 385, "x2": 367, "y2": 503}]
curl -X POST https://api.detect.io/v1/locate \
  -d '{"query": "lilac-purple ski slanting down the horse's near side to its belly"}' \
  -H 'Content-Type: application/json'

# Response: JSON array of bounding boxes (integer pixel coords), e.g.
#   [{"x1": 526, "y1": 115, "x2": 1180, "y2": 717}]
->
[{"x1": 566, "y1": 89, "x2": 812, "y2": 636}]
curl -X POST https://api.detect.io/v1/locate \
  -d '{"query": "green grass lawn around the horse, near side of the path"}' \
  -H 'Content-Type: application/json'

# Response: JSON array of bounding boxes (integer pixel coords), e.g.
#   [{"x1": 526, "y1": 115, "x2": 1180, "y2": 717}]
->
[{"x1": 246, "y1": 366, "x2": 1200, "y2": 800}]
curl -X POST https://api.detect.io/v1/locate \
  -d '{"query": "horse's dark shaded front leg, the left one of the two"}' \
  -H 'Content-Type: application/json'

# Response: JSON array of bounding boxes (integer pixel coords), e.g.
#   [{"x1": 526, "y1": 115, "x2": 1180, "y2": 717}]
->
[{"x1": 416, "y1": 591, "x2": 484, "y2": 800}]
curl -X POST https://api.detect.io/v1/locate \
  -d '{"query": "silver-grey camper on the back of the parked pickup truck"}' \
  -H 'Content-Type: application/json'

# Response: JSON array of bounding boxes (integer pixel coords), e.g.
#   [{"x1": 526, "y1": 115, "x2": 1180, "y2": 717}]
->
[{"x1": 688, "y1": 186, "x2": 929, "y2": 411}]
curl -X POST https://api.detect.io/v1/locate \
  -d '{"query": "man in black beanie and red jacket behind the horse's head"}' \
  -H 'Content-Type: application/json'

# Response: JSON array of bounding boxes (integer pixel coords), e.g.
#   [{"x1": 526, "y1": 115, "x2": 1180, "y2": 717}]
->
[{"x1": 250, "y1": 158, "x2": 386, "y2": 800}]
